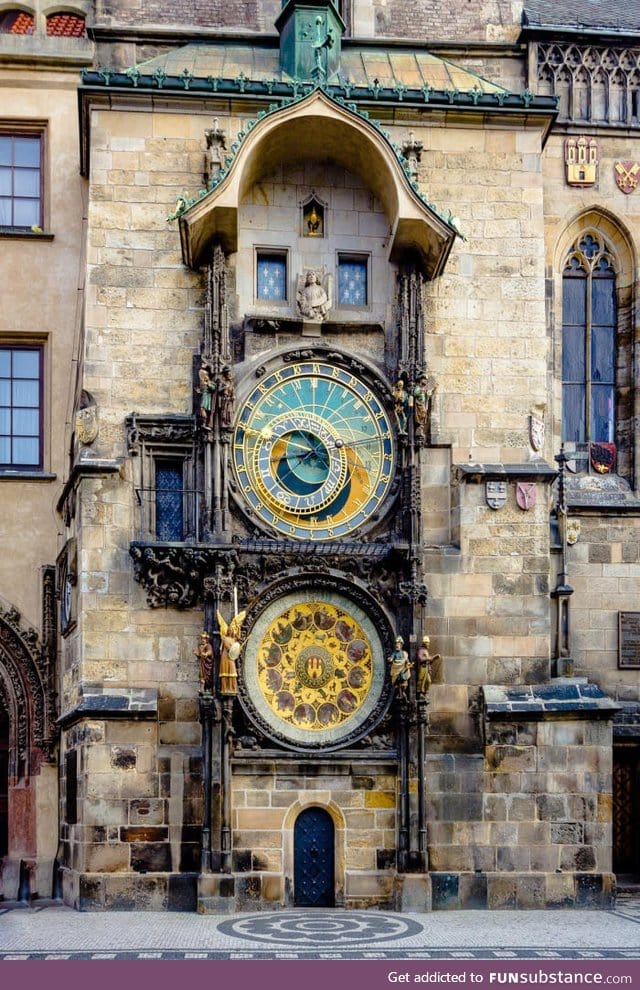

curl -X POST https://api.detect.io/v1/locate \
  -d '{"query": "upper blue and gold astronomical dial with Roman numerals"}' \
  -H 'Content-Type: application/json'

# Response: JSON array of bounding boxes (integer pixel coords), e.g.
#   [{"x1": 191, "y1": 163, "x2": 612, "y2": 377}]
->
[{"x1": 233, "y1": 361, "x2": 395, "y2": 541}]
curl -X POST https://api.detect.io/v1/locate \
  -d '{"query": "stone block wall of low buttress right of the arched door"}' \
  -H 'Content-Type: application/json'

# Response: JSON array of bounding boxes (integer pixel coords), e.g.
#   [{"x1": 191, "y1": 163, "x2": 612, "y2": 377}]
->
[{"x1": 426, "y1": 719, "x2": 613, "y2": 910}]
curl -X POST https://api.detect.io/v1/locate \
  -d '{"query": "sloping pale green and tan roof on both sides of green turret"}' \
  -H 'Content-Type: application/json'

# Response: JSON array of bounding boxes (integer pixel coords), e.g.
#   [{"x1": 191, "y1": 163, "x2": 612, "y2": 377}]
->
[{"x1": 129, "y1": 43, "x2": 508, "y2": 94}]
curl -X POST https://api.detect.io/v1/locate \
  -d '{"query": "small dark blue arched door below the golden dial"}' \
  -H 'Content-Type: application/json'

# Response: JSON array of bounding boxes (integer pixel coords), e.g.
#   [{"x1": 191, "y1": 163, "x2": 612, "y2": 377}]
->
[{"x1": 293, "y1": 807, "x2": 335, "y2": 907}]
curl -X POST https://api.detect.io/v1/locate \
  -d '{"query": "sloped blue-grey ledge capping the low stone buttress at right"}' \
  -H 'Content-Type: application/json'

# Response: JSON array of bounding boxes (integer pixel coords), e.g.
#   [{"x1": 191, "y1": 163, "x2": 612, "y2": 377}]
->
[{"x1": 482, "y1": 677, "x2": 620, "y2": 720}]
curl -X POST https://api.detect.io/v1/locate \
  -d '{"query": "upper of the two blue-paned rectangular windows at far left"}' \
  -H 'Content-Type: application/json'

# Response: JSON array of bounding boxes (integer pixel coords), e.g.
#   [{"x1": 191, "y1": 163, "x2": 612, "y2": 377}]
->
[{"x1": 0, "y1": 131, "x2": 43, "y2": 230}]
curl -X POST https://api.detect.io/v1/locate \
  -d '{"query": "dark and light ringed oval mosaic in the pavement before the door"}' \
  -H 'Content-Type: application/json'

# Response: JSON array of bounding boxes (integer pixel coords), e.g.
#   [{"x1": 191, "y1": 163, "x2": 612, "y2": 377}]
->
[{"x1": 217, "y1": 909, "x2": 423, "y2": 948}]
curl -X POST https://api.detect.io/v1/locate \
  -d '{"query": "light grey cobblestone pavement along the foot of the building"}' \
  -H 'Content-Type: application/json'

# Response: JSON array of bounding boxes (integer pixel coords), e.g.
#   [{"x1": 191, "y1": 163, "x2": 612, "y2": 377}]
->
[{"x1": 0, "y1": 895, "x2": 640, "y2": 961}]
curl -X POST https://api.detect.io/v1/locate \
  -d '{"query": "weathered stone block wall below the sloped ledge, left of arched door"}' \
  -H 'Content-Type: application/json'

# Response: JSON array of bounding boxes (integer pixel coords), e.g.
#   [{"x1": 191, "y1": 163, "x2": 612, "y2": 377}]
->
[{"x1": 62, "y1": 712, "x2": 203, "y2": 910}]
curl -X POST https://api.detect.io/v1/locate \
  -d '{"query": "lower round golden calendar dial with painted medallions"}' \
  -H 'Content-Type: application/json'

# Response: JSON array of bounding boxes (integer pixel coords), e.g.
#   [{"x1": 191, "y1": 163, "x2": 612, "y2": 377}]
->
[{"x1": 244, "y1": 590, "x2": 384, "y2": 746}]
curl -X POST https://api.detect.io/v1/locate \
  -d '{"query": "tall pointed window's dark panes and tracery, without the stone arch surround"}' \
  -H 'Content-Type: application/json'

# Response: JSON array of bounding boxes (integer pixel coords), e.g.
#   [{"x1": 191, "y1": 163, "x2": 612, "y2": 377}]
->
[{"x1": 562, "y1": 231, "x2": 617, "y2": 444}]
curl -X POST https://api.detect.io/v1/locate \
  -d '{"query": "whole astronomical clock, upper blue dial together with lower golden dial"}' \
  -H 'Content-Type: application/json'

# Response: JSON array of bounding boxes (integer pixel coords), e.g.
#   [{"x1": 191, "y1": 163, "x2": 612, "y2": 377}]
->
[{"x1": 230, "y1": 348, "x2": 397, "y2": 752}]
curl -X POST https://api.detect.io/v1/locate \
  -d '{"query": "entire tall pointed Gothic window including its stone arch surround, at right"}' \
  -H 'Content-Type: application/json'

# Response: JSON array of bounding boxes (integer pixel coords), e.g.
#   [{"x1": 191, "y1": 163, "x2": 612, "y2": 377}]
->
[{"x1": 556, "y1": 211, "x2": 637, "y2": 487}]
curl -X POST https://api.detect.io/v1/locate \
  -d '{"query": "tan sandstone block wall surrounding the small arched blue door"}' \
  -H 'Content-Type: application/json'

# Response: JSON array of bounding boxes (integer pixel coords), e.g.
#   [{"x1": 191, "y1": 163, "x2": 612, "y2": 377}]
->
[{"x1": 199, "y1": 756, "x2": 397, "y2": 913}]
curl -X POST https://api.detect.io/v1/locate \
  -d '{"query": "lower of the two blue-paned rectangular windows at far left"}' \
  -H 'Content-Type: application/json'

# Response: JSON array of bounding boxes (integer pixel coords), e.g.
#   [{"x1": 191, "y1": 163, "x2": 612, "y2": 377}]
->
[{"x1": 0, "y1": 347, "x2": 42, "y2": 470}]
